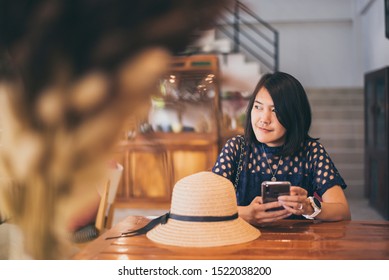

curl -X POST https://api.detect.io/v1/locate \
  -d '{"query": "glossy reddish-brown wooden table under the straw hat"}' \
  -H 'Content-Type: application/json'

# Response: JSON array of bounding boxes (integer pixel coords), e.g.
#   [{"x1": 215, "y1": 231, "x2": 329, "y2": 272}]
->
[{"x1": 74, "y1": 216, "x2": 389, "y2": 260}]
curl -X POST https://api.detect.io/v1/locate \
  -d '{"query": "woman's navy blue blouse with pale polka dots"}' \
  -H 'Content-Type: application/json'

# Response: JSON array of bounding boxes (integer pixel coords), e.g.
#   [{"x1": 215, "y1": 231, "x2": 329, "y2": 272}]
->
[{"x1": 212, "y1": 135, "x2": 347, "y2": 206}]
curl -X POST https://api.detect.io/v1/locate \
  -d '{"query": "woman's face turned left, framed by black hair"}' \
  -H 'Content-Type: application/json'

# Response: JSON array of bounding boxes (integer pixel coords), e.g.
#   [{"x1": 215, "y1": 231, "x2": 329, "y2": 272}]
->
[{"x1": 251, "y1": 87, "x2": 286, "y2": 147}]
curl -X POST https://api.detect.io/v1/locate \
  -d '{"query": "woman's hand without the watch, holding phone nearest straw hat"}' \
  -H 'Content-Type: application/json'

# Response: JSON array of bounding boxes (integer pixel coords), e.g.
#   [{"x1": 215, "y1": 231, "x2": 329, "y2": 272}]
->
[{"x1": 238, "y1": 196, "x2": 291, "y2": 226}]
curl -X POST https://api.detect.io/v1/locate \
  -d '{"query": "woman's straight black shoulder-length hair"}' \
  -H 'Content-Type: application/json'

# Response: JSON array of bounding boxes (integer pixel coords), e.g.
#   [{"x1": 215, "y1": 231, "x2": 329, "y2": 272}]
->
[{"x1": 245, "y1": 72, "x2": 312, "y2": 156}]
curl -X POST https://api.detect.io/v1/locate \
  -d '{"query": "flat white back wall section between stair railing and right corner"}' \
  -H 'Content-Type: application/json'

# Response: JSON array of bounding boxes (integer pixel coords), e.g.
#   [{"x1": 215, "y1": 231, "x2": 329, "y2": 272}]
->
[{"x1": 274, "y1": 21, "x2": 358, "y2": 88}]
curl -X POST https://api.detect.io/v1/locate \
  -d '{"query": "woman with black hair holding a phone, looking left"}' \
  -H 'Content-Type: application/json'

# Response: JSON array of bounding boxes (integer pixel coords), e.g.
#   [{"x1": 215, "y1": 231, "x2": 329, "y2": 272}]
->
[{"x1": 212, "y1": 72, "x2": 351, "y2": 225}]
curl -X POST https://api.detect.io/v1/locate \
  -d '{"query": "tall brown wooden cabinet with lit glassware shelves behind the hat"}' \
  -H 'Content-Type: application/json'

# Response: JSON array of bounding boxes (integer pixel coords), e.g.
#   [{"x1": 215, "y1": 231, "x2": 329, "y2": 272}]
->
[{"x1": 115, "y1": 55, "x2": 221, "y2": 207}]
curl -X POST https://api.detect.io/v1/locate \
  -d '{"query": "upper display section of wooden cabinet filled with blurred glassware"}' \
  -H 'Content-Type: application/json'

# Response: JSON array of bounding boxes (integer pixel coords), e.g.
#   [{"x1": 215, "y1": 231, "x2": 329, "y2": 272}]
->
[{"x1": 149, "y1": 71, "x2": 217, "y2": 133}]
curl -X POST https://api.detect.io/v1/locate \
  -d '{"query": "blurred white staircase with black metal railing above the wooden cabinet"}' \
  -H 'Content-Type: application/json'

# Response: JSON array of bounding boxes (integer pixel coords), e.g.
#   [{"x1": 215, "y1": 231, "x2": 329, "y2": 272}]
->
[{"x1": 185, "y1": 0, "x2": 279, "y2": 86}]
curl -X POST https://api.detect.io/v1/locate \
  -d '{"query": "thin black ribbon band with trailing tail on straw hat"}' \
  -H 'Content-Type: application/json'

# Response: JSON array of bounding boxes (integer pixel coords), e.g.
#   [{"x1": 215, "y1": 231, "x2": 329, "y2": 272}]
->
[{"x1": 105, "y1": 212, "x2": 239, "y2": 240}]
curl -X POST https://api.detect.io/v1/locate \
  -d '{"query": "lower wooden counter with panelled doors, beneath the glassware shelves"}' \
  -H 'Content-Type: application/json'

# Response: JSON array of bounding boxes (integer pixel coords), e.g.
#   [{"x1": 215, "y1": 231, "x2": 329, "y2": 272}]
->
[{"x1": 114, "y1": 132, "x2": 219, "y2": 208}]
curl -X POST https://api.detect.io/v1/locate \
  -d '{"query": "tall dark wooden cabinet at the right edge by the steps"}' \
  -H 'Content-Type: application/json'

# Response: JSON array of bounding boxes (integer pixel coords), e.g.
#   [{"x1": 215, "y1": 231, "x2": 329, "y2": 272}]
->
[{"x1": 365, "y1": 67, "x2": 389, "y2": 219}]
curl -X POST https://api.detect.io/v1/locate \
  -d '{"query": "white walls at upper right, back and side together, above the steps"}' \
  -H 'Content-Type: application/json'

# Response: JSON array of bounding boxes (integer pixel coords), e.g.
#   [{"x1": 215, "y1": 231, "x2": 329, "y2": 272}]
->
[{"x1": 242, "y1": 0, "x2": 389, "y2": 88}]
